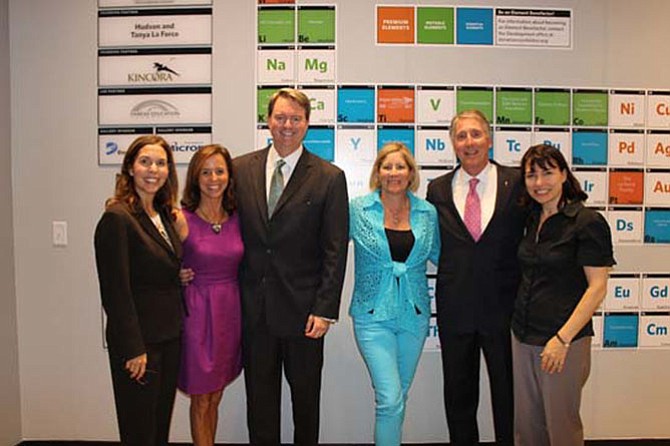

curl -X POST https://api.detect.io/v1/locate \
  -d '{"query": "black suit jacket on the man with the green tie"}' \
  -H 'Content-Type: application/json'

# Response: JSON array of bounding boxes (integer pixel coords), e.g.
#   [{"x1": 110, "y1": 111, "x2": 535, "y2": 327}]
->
[{"x1": 234, "y1": 147, "x2": 349, "y2": 336}]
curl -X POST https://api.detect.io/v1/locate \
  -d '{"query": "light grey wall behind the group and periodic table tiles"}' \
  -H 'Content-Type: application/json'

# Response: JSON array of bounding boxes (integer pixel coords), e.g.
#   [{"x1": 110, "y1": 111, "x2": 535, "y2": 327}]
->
[{"x1": 9, "y1": 0, "x2": 670, "y2": 443}]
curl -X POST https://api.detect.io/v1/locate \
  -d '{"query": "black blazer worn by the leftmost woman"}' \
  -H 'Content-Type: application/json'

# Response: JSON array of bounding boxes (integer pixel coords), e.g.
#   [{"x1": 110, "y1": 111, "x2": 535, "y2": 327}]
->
[{"x1": 95, "y1": 203, "x2": 183, "y2": 359}]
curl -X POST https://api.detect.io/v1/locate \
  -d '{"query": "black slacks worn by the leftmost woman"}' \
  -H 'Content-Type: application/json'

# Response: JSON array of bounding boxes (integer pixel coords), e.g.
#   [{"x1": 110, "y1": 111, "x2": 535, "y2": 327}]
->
[{"x1": 108, "y1": 338, "x2": 181, "y2": 446}]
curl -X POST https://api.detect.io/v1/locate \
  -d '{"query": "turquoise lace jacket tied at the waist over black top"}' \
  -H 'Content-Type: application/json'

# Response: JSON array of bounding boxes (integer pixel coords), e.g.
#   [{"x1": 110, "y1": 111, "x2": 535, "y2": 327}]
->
[{"x1": 349, "y1": 191, "x2": 440, "y2": 329}]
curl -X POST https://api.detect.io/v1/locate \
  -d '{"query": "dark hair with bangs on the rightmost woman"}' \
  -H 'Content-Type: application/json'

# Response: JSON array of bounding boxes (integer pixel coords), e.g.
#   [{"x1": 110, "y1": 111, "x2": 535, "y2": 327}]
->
[{"x1": 519, "y1": 144, "x2": 589, "y2": 209}]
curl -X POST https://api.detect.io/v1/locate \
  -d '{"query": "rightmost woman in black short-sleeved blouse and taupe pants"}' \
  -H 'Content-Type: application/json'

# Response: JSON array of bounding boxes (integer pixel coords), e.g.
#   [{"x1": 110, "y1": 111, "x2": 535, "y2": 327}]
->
[{"x1": 512, "y1": 144, "x2": 615, "y2": 446}]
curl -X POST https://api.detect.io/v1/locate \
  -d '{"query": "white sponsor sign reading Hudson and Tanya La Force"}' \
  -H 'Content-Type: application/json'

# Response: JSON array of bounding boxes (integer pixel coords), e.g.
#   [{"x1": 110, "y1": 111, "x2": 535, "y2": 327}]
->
[{"x1": 98, "y1": 8, "x2": 212, "y2": 47}]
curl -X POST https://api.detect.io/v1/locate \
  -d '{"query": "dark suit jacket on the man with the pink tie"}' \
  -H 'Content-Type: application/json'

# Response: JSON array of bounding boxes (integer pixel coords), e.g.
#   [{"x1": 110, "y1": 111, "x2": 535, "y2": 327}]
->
[{"x1": 427, "y1": 163, "x2": 526, "y2": 334}]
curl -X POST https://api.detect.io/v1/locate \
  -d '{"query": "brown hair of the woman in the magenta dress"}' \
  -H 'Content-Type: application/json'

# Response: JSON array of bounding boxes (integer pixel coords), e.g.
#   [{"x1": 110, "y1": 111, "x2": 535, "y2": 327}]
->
[{"x1": 181, "y1": 144, "x2": 237, "y2": 214}]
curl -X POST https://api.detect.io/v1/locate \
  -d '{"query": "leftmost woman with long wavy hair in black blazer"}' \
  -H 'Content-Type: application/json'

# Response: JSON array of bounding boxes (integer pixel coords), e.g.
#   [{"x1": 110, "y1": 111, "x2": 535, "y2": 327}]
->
[{"x1": 95, "y1": 135, "x2": 183, "y2": 446}]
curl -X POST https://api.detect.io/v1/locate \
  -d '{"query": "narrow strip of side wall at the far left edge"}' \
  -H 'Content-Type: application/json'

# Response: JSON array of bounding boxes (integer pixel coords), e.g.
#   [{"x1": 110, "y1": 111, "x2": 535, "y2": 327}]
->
[{"x1": 0, "y1": 0, "x2": 21, "y2": 444}]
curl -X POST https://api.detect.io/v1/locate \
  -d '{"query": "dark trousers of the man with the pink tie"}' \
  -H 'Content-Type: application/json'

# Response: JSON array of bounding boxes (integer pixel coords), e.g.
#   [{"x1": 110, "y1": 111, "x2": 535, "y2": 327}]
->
[{"x1": 439, "y1": 330, "x2": 514, "y2": 446}]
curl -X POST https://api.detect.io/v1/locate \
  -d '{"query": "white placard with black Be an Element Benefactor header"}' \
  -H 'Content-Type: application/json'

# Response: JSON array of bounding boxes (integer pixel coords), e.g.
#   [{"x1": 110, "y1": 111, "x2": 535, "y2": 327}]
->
[{"x1": 495, "y1": 8, "x2": 572, "y2": 49}]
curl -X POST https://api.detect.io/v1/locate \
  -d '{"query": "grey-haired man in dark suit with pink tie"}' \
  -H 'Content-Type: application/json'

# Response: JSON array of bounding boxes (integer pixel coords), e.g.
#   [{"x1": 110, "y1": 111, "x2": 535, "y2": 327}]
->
[{"x1": 427, "y1": 110, "x2": 524, "y2": 446}]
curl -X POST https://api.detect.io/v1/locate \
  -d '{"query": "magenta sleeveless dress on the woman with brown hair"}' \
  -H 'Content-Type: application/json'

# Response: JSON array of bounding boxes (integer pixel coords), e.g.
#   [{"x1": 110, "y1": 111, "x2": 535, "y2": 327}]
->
[{"x1": 178, "y1": 209, "x2": 244, "y2": 395}]
